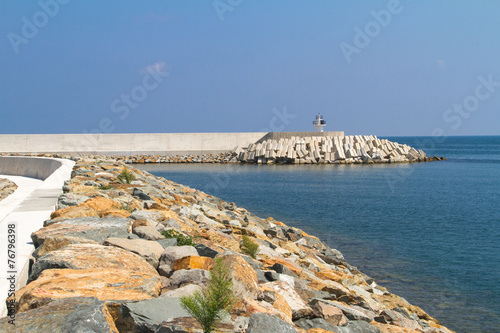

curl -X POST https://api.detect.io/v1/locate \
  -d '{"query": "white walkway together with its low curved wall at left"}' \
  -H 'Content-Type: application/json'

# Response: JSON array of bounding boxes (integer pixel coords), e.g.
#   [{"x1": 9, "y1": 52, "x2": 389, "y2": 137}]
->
[{"x1": 0, "y1": 156, "x2": 75, "y2": 317}]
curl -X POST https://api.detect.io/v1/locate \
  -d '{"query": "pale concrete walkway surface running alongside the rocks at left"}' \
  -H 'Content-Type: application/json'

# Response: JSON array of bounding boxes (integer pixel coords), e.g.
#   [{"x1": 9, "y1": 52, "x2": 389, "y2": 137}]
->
[{"x1": 0, "y1": 160, "x2": 74, "y2": 317}]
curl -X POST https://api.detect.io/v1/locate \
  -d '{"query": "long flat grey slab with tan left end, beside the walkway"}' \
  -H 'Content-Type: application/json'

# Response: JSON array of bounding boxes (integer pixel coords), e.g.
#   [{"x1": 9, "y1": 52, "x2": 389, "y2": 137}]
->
[{"x1": 31, "y1": 217, "x2": 130, "y2": 247}]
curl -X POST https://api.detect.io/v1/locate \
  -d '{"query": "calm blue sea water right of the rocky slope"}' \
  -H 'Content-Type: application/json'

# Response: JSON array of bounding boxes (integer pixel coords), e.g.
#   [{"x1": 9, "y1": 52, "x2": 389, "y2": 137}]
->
[{"x1": 141, "y1": 136, "x2": 500, "y2": 333}]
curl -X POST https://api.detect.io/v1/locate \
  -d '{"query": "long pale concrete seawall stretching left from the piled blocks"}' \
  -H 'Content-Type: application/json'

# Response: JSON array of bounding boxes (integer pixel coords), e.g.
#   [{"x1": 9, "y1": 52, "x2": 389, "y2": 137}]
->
[{"x1": 0, "y1": 132, "x2": 267, "y2": 154}]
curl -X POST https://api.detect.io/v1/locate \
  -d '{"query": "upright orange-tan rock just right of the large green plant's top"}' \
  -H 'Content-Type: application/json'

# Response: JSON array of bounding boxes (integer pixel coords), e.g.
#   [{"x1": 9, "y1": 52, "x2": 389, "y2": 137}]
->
[{"x1": 221, "y1": 254, "x2": 261, "y2": 299}]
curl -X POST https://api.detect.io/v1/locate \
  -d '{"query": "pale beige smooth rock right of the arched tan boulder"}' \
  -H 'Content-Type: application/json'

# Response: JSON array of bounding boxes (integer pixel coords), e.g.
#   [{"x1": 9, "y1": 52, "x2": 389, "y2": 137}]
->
[{"x1": 104, "y1": 238, "x2": 163, "y2": 268}]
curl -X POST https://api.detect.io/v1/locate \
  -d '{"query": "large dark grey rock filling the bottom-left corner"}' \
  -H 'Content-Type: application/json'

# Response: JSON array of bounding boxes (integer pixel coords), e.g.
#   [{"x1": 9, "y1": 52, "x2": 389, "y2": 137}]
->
[{"x1": 0, "y1": 297, "x2": 116, "y2": 333}]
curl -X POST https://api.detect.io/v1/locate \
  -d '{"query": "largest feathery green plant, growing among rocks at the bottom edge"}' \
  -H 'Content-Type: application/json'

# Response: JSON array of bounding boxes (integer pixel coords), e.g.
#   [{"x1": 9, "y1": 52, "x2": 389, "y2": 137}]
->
[{"x1": 180, "y1": 258, "x2": 235, "y2": 333}]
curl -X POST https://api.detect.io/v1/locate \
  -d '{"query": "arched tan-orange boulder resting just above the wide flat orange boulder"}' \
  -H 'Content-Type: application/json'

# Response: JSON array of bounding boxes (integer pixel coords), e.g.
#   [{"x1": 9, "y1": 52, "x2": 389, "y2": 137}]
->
[{"x1": 28, "y1": 244, "x2": 156, "y2": 283}]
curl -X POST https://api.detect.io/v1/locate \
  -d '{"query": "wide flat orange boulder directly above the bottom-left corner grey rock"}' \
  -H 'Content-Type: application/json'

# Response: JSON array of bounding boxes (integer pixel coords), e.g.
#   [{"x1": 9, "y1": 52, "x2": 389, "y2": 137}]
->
[{"x1": 12, "y1": 268, "x2": 162, "y2": 313}]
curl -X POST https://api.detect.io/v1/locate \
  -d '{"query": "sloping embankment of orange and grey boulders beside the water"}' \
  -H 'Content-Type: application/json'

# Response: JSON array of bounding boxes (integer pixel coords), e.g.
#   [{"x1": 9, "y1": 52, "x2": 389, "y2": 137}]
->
[{"x1": 0, "y1": 156, "x2": 452, "y2": 333}]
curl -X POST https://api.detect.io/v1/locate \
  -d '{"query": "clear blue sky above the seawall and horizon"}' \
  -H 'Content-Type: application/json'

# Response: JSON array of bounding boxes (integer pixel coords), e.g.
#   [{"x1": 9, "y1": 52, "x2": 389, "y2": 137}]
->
[{"x1": 0, "y1": 0, "x2": 500, "y2": 136}]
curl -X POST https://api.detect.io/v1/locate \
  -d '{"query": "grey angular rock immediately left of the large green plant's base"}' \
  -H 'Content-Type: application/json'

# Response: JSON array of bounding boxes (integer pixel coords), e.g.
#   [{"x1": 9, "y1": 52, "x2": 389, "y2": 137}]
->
[{"x1": 122, "y1": 297, "x2": 191, "y2": 333}]
